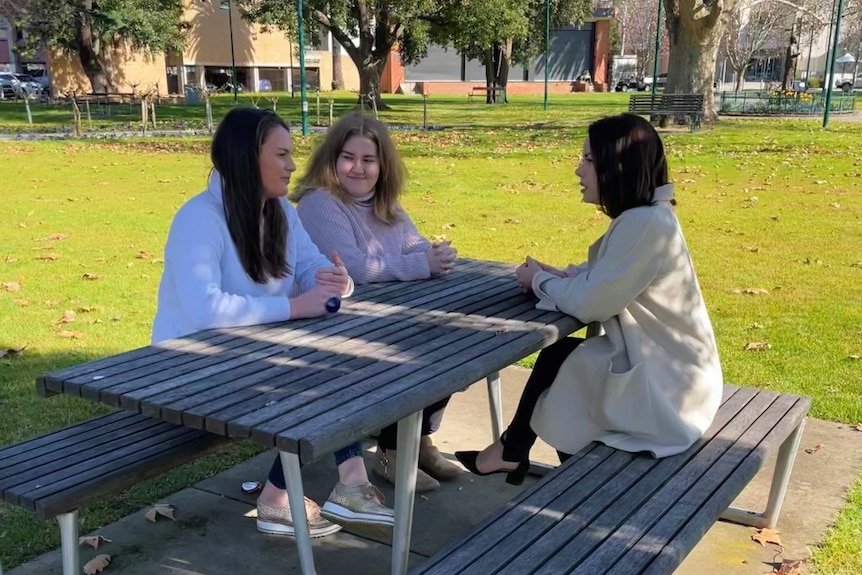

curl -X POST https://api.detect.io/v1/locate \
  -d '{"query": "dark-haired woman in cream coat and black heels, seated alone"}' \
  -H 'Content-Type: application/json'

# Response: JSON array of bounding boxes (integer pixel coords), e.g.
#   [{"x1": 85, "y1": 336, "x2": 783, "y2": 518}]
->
[{"x1": 455, "y1": 114, "x2": 723, "y2": 485}]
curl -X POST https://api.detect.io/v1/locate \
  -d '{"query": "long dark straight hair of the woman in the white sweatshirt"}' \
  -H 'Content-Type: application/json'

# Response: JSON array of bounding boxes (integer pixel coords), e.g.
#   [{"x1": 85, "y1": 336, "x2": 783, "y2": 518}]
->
[{"x1": 210, "y1": 108, "x2": 290, "y2": 284}]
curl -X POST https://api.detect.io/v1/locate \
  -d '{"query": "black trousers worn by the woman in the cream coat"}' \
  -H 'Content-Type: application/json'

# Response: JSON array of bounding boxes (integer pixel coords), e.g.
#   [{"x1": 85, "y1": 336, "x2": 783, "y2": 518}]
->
[{"x1": 503, "y1": 337, "x2": 584, "y2": 461}]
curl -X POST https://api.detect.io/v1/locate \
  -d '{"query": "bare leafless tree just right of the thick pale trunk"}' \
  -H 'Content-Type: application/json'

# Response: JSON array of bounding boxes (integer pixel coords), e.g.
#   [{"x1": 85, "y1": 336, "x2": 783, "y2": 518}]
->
[{"x1": 723, "y1": 0, "x2": 788, "y2": 92}]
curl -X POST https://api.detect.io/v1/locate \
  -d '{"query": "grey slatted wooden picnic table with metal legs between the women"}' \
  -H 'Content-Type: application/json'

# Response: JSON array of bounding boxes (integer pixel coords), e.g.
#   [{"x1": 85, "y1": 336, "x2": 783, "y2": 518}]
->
[{"x1": 37, "y1": 260, "x2": 583, "y2": 575}]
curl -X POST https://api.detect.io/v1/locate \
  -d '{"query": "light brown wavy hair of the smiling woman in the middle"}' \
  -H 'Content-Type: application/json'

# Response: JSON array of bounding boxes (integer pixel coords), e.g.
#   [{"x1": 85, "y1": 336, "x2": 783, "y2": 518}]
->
[{"x1": 290, "y1": 112, "x2": 407, "y2": 224}]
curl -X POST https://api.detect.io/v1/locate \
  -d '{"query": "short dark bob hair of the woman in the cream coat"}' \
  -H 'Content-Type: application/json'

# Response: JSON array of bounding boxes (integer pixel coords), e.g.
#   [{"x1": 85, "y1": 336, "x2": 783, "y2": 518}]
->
[{"x1": 587, "y1": 114, "x2": 668, "y2": 218}]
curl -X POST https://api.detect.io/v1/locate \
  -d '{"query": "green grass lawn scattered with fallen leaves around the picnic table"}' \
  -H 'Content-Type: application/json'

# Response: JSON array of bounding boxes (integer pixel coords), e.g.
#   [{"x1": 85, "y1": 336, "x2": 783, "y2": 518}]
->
[{"x1": 0, "y1": 99, "x2": 862, "y2": 575}]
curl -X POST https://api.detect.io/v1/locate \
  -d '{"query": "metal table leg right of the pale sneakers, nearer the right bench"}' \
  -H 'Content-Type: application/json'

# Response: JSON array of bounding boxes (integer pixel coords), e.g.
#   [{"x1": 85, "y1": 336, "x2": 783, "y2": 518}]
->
[{"x1": 392, "y1": 411, "x2": 422, "y2": 575}]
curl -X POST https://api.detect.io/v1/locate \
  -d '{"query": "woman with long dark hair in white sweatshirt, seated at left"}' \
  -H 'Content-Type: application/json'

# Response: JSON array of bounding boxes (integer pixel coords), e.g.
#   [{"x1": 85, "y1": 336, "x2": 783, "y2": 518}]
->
[{"x1": 152, "y1": 108, "x2": 394, "y2": 537}]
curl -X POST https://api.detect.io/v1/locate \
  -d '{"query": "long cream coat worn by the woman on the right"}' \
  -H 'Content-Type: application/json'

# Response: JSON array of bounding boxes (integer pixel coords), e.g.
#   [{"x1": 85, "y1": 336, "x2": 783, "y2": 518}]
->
[{"x1": 531, "y1": 185, "x2": 723, "y2": 457}]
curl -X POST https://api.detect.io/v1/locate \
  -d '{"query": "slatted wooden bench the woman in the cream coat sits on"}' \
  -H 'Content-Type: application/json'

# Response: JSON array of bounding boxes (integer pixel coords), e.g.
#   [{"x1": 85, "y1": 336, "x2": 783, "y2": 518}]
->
[{"x1": 411, "y1": 386, "x2": 811, "y2": 575}]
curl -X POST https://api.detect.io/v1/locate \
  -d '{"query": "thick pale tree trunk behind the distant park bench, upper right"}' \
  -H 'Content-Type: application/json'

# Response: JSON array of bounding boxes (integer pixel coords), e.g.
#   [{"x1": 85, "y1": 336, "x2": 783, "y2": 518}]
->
[{"x1": 664, "y1": 0, "x2": 723, "y2": 123}]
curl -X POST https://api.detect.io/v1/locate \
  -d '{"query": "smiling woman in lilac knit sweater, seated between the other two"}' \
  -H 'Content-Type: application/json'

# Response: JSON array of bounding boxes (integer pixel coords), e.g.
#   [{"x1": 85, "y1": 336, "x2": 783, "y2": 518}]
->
[{"x1": 291, "y1": 113, "x2": 463, "y2": 492}]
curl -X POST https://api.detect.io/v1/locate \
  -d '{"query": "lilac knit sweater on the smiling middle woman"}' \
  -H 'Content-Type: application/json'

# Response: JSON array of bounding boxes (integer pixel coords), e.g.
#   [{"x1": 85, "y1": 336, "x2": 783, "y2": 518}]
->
[{"x1": 296, "y1": 190, "x2": 431, "y2": 285}]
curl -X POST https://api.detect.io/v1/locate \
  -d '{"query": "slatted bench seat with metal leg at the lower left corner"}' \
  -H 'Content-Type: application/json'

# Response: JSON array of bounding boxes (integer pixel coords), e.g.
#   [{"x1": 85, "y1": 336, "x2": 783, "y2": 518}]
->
[{"x1": 0, "y1": 411, "x2": 227, "y2": 575}]
